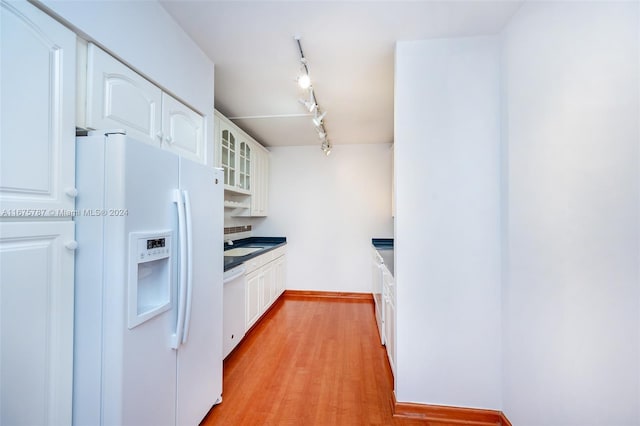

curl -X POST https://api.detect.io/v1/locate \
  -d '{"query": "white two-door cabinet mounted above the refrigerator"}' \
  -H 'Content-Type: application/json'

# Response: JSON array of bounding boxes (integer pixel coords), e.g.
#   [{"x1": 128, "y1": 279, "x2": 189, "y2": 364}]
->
[{"x1": 84, "y1": 43, "x2": 205, "y2": 163}]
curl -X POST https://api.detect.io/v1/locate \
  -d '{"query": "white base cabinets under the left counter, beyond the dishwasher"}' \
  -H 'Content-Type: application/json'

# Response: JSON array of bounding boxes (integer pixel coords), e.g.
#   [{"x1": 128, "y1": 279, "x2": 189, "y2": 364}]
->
[{"x1": 245, "y1": 247, "x2": 286, "y2": 330}]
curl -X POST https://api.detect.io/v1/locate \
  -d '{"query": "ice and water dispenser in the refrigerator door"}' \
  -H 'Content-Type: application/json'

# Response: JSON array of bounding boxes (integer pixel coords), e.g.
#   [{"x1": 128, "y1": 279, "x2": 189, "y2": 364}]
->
[{"x1": 127, "y1": 230, "x2": 172, "y2": 329}]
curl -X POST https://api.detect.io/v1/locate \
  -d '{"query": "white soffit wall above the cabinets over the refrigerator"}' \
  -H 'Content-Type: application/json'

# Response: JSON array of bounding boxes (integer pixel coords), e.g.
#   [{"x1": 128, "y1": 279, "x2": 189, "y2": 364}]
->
[{"x1": 40, "y1": 0, "x2": 214, "y2": 114}]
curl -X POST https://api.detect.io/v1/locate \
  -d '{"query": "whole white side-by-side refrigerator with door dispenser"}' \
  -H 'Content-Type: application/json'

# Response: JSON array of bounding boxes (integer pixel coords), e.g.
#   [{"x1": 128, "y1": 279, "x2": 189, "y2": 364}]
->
[{"x1": 73, "y1": 132, "x2": 223, "y2": 426}]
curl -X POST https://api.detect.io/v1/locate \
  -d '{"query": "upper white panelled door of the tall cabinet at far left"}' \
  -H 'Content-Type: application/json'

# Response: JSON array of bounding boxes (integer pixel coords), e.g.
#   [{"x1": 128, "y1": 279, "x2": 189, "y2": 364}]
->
[{"x1": 0, "y1": 1, "x2": 76, "y2": 214}]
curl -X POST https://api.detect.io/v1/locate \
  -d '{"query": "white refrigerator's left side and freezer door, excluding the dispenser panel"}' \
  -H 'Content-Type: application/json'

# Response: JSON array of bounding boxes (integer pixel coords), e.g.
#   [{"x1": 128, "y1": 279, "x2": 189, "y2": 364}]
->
[{"x1": 74, "y1": 135, "x2": 179, "y2": 426}]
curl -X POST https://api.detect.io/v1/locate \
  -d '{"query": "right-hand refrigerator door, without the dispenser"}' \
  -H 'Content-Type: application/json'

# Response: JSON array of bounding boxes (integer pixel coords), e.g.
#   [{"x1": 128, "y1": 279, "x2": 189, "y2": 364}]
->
[{"x1": 176, "y1": 159, "x2": 224, "y2": 425}]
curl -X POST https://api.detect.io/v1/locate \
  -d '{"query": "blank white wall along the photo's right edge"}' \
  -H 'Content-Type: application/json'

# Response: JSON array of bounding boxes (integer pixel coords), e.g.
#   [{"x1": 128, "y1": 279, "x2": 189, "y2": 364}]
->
[{"x1": 503, "y1": 2, "x2": 640, "y2": 426}]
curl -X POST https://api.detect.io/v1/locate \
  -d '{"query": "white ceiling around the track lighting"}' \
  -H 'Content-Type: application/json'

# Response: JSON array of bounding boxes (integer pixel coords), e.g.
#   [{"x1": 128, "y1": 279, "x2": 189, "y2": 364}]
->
[{"x1": 161, "y1": 0, "x2": 520, "y2": 146}]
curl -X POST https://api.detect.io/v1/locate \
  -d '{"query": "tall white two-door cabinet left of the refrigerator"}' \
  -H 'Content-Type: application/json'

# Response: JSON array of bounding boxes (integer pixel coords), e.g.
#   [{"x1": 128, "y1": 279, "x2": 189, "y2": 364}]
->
[{"x1": 0, "y1": 1, "x2": 76, "y2": 425}]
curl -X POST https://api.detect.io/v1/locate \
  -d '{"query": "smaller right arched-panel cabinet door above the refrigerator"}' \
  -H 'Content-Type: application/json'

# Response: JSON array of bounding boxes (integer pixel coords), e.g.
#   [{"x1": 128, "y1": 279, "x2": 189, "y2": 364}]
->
[{"x1": 162, "y1": 93, "x2": 205, "y2": 164}]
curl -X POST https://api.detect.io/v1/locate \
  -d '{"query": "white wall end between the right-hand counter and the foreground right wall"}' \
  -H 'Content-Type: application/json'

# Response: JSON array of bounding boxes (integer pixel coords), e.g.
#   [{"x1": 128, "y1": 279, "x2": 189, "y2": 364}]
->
[{"x1": 395, "y1": 37, "x2": 502, "y2": 409}]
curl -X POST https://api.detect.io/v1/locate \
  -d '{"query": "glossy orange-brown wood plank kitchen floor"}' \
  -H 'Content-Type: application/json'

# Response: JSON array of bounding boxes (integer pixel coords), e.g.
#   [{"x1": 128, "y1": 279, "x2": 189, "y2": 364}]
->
[{"x1": 201, "y1": 296, "x2": 424, "y2": 426}]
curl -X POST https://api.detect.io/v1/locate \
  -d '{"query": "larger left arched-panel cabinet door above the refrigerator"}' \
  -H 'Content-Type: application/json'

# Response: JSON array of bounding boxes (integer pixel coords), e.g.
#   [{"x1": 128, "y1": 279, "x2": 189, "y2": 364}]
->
[{"x1": 87, "y1": 43, "x2": 162, "y2": 146}]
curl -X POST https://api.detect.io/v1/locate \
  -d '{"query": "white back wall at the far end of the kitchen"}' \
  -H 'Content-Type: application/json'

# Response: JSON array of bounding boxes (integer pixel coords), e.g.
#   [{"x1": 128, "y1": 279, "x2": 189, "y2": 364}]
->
[{"x1": 253, "y1": 144, "x2": 393, "y2": 292}]
